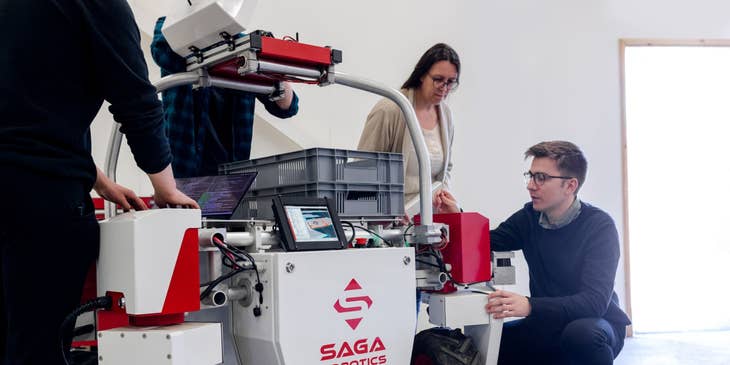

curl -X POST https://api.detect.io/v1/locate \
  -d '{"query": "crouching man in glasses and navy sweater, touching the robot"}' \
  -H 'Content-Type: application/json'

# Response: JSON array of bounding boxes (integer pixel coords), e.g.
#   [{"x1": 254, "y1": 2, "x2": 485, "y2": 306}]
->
[{"x1": 486, "y1": 141, "x2": 631, "y2": 365}]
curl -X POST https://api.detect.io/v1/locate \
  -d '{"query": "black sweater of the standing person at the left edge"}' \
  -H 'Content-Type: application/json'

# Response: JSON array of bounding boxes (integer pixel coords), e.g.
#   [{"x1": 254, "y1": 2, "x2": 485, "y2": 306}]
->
[{"x1": 0, "y1": 0, "x2": 171, "y2": 191}]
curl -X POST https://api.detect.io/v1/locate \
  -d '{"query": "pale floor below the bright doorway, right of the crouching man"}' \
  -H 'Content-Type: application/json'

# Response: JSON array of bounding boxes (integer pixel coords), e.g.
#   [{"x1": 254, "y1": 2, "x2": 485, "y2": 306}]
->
[{"x1": 614, "y1": 331, "x2": 730, "y2": 365}]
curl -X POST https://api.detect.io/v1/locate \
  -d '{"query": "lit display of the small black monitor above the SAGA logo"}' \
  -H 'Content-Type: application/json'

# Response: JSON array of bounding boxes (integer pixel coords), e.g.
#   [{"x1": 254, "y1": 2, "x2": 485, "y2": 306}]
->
[{"x1": 284, "y1": 205, "x2": 339, "y2": 242}]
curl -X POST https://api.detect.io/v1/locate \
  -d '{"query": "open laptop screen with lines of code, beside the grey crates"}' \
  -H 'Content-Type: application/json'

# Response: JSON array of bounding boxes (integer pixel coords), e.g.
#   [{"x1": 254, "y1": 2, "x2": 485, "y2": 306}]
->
[{"x1": 175, "y1": 172, "x2": 257, "y2": 219}]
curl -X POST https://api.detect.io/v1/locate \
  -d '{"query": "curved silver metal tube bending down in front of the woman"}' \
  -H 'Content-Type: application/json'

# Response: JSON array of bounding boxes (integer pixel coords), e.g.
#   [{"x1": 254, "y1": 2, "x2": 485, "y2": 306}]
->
[{"x1": 334, "y1": 72, "x2": 433, "y2": 226}]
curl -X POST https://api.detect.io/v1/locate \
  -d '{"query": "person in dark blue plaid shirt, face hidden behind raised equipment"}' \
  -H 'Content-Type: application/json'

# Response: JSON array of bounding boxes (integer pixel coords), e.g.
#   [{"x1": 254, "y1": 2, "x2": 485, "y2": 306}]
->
[{"x1": 151, "y1": 17, "x2": 299, "y2": 177}]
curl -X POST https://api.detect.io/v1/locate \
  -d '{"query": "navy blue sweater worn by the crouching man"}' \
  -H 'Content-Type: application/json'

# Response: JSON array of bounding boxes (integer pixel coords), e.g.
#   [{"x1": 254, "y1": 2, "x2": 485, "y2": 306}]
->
[{"x1": 490, "y1": 203, "x2": 631, "y2": 326}]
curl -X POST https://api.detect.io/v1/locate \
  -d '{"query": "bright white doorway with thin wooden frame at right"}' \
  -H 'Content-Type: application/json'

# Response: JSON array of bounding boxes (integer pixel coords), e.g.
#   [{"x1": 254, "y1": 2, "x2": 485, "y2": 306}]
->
[{"x1": 621, "y1": 40, "x2": 730, "y2": 333}]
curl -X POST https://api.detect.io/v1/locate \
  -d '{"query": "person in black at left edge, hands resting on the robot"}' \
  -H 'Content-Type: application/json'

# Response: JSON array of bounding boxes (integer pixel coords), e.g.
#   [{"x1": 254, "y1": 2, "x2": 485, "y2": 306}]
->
[{"x1": 0, "y1": 0, "x2": 197, "y2": 365}]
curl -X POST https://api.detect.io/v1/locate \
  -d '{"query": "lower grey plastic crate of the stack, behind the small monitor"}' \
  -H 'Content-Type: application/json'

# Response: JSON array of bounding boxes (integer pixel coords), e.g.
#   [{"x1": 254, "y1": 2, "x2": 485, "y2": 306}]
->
[{"x1": 233, "y1": 183, "x2": 404, "y2": 219}]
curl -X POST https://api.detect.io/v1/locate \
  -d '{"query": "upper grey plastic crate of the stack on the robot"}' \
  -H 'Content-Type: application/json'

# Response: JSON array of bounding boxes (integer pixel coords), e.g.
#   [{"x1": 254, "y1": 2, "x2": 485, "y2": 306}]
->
[{"x1": 218, "y1": 148, "x2": 403, "y2": 191}]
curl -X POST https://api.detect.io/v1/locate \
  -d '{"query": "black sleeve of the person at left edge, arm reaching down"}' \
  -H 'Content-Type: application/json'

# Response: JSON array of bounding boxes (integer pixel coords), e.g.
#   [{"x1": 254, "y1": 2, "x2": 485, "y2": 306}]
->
[{"x1": 85, "y1": 0, "x2": 171, "y2": 173}]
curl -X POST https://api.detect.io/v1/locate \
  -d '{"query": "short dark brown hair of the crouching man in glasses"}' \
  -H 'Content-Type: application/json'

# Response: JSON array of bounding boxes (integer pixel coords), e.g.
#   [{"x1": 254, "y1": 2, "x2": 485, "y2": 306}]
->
[{"x1": 525, "y1": 141, "x2": 588, "y2": 194}]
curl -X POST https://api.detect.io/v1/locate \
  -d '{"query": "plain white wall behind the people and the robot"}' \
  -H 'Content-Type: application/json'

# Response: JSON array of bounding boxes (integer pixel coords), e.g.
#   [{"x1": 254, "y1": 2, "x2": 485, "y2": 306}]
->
[{"x1": 95, "y1": 0, "x2": 730, "y2": 310}]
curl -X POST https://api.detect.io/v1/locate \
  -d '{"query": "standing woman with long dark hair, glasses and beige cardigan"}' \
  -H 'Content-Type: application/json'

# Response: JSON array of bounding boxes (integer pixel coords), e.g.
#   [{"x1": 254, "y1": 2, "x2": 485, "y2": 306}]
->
[{"x1": 358, "y1": 43, "x2": 461, "y2": 212}]
